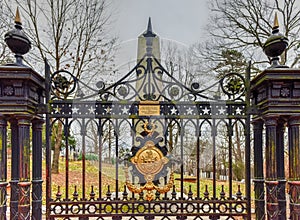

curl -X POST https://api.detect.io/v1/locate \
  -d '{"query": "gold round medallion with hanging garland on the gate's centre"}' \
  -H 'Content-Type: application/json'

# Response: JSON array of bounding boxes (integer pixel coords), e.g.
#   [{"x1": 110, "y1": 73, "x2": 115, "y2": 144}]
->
[{"x1": 125, "y1": 141, "x2": 174, "y2": 201}]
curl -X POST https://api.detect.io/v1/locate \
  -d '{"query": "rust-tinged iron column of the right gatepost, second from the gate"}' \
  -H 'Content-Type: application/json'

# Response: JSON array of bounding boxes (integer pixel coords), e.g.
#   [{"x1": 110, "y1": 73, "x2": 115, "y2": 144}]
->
[{"x1": 265, "y1": 117, "x2": 279, "y2": 220}]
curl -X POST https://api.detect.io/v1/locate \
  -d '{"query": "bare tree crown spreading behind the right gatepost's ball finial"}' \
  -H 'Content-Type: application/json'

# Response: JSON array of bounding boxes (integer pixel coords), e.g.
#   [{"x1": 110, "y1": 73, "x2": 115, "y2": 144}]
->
[{"x1": 194, "y1": 0, "x2": 300, "y2": 74}]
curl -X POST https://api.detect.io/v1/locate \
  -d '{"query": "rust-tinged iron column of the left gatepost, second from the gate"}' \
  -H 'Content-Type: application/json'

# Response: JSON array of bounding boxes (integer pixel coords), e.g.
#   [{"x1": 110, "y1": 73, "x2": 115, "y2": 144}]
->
[{"x1": 17, "y1": 116, "x2": 31, "y2": 220}]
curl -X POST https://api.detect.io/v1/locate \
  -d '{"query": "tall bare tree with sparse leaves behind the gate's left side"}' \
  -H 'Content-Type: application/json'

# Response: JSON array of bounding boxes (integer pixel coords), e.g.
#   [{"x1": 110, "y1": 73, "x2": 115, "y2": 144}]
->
[{"x1": 5, "y1": 0, "x2": 115, "y2": 173}]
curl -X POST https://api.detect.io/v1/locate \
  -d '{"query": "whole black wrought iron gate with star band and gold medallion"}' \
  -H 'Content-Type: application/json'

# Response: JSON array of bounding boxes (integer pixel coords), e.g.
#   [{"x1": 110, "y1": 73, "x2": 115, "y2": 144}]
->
[{"x1": 46, "y1": 51, "x2": 251, "y2": 219}]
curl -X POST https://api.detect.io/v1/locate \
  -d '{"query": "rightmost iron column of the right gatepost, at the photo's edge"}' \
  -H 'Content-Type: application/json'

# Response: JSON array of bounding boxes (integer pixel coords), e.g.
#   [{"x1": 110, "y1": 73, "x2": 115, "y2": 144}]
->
[{"x1": 288, "y1": 116, "x2": 300, "y2": 220}]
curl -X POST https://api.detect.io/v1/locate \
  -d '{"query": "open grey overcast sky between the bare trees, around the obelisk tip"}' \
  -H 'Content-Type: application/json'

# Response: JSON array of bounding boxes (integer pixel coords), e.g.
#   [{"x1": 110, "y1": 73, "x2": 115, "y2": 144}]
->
[{"x1": 111, "y1": 0, "x2": 209, "y2": 67}]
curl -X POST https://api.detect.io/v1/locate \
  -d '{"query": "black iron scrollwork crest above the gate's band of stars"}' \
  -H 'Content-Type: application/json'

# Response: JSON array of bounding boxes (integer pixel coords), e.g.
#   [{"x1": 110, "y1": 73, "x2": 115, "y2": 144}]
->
[{"x1": 51, "y1": 57, "x2": 245, "y2": 101}]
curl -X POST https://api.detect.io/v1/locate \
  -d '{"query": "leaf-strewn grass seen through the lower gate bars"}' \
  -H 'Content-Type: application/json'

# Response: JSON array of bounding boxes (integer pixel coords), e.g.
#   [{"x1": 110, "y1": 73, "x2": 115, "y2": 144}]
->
[{"x1": 48, "y1": 158, "x2": 254, "y2": 203}]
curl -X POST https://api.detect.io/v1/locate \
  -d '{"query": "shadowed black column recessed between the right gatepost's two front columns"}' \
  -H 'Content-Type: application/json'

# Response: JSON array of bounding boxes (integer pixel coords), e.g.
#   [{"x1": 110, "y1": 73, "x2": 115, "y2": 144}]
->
[{"x1": 276, "y1": 120, "x2": 286, "y2": 220}]
